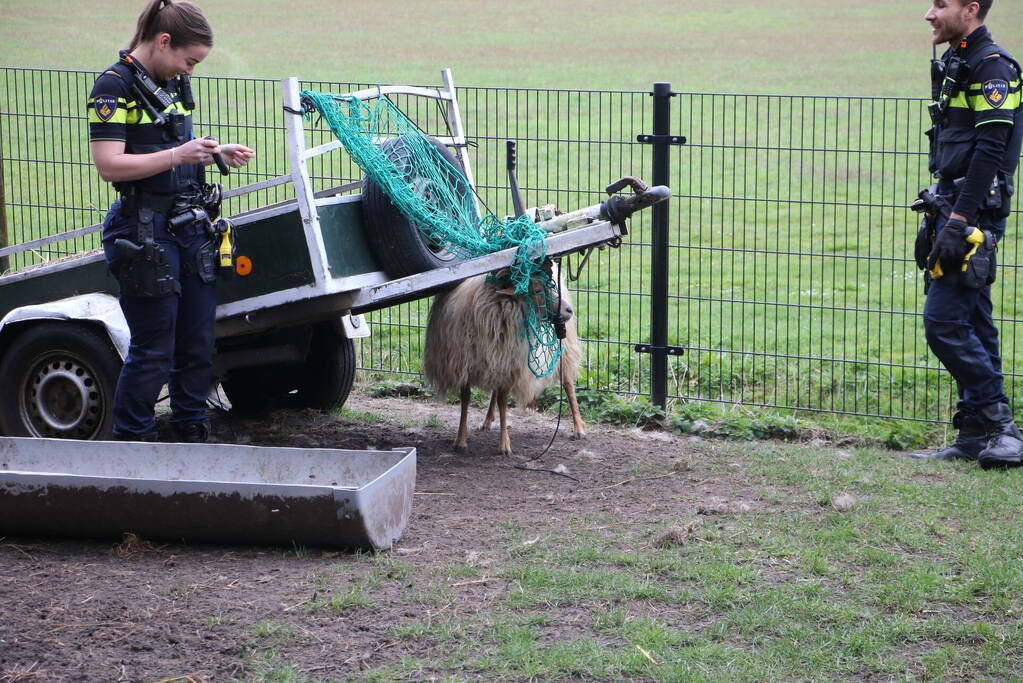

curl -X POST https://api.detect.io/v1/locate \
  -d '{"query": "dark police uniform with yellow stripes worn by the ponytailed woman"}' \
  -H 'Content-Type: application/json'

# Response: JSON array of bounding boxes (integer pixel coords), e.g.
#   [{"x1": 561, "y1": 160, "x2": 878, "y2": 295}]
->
[{"x1": 87, "y1": 53, "x2": 216, "y2": 441}]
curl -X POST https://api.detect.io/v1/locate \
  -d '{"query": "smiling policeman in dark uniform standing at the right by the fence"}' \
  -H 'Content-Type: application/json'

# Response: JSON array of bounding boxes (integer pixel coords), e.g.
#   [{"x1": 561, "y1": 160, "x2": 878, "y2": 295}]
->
[{"x1": 915, "y1": 0, "x2": 1023, "y2": 467}]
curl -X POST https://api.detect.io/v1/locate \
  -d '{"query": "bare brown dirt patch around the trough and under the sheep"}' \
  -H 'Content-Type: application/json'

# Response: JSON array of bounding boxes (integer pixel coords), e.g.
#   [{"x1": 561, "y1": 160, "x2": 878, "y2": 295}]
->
[{"x1": 0, "y1": 386, "x2": 757, "y2": 682}]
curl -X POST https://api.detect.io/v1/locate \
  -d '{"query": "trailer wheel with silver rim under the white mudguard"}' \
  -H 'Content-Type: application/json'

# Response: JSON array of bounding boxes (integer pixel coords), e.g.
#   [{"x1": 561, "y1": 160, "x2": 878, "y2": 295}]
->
[{"x1": 0, "y1": 322, "x2": 122, "y2": 440}]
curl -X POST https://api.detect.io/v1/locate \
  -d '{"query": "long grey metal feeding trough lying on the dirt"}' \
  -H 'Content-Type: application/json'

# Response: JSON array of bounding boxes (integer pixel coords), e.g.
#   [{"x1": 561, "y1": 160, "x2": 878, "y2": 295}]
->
[{"x1": 0, "y1": 438, "x2": 415, "y2": 548}]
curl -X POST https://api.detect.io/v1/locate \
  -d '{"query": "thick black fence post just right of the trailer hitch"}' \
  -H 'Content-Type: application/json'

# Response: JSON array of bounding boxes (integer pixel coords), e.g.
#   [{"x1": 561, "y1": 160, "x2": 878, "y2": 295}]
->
[{"x1": 635, "y1": 83, "x2": 685, "y2": 408}]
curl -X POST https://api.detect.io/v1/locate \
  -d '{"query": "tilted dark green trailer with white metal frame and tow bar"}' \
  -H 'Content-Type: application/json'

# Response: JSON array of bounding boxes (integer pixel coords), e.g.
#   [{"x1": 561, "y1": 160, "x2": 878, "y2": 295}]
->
[{"x1": 0, "y1": 70, "x2": 668, "y2": 439}]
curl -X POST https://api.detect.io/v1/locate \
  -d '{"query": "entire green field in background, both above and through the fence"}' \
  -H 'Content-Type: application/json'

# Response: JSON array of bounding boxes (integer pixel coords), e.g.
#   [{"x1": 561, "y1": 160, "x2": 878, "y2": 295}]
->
[{"x1": 0, "y1": 0, "x2": 1023, "y2": 419}]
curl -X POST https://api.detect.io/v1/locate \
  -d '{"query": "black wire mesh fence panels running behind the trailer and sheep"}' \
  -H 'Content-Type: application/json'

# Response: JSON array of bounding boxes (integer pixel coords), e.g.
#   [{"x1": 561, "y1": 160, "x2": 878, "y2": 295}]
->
[{"x1": 0, "y1": 69, "x2": 1023, "y2": 420}]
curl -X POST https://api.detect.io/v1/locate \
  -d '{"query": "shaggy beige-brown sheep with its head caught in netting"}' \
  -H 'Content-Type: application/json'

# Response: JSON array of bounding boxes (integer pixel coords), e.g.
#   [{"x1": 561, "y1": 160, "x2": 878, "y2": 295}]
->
[{"x1": 422, "y1": 258, "x2": 586, "y2": 455}]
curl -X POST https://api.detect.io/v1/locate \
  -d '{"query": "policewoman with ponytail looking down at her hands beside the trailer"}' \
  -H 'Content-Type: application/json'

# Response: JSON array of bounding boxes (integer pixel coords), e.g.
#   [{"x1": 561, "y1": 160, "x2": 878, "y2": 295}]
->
[{"x1": 87, "y1": 0, "x2": 255, "y2": 443}]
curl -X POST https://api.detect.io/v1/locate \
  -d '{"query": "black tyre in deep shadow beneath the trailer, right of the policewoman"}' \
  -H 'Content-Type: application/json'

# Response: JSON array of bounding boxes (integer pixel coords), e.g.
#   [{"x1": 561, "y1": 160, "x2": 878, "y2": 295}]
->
[{"x1": 221, "y1": 323, "x2": 355, "y2": 413}]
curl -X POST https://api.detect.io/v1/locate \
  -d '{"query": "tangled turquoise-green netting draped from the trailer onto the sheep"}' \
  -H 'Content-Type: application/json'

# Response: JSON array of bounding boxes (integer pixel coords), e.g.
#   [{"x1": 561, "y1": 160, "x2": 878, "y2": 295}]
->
[{"x1": 301, "y1": 90, "x2": 561, "y2": 377}]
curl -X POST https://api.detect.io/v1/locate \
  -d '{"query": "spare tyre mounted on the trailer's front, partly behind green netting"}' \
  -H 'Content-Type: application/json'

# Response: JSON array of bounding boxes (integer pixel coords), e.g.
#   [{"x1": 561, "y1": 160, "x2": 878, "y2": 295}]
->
[{"x1": 362, "y1": 135, "x2": 472, "y2": 278}]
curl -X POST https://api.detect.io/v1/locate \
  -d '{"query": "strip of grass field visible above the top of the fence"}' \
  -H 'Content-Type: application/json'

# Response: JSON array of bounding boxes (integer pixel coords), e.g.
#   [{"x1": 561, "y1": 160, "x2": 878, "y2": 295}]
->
[{"x1": 6, "y1": 0, "x2": 1023, "y2": 96}]
